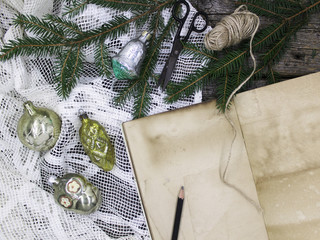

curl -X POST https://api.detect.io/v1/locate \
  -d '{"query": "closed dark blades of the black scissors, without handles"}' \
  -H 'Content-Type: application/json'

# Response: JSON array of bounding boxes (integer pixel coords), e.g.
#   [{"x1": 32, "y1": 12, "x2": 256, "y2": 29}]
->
[{"x1": 158, "y1": 40, "x2": 183, "y2": 90}]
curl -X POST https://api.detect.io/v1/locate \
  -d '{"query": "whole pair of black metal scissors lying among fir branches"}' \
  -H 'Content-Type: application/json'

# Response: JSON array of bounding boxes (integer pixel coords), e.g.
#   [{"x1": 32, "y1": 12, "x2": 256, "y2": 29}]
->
[{"x1": 157, "y1": 0, "x2": 208, "y2": 90}]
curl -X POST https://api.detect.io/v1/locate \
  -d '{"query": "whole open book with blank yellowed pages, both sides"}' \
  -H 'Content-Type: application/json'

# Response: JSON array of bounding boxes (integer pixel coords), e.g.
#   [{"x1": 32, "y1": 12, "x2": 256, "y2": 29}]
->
[{"x1": 123, "y1": 73, "x2": 320, "y2": 240}]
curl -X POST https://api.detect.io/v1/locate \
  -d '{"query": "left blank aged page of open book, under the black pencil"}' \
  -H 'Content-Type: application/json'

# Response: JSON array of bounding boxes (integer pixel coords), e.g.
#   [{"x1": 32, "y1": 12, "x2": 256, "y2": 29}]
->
[{"x1": 123, "y1": 102, "x2": 268, "y2": 240}]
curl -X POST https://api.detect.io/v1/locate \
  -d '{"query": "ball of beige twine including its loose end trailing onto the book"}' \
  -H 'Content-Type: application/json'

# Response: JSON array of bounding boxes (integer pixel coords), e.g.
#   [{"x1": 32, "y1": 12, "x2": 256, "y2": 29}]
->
[{"x1": 205, "y1": 5, "x2": 262, "y2": 213}]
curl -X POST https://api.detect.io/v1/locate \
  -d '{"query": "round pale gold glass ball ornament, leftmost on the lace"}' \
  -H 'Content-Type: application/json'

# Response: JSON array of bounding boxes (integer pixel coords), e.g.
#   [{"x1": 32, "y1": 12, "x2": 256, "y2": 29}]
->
[{"x1": 17, "y1": 101, "x2": 61, "y2": 152}]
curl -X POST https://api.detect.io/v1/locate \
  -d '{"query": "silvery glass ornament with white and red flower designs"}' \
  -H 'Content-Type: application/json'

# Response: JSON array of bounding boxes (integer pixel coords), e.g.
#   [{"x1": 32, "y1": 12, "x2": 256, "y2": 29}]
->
[{"x1": 49, "y1": 173, "x2": 101, "y2": 214}]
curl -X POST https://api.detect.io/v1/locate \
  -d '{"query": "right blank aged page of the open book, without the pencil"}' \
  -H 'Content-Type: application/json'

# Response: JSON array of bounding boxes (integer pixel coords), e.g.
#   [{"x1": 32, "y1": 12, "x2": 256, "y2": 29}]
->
[{"x1": 235, "y1": 73, "x2": 320, "y2": 240}]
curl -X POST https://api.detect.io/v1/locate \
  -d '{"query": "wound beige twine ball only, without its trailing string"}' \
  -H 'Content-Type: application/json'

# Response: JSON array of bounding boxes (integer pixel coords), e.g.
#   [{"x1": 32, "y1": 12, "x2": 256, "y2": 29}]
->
[{"x1": 204, "y1": 5, "x2": 260, "y2": 51}]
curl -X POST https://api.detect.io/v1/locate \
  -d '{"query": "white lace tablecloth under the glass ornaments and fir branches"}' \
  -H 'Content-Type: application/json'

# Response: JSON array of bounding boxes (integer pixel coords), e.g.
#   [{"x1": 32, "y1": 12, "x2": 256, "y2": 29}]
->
[{"x1": 0, "y1": 0, "x2": 209, "y2": 240}]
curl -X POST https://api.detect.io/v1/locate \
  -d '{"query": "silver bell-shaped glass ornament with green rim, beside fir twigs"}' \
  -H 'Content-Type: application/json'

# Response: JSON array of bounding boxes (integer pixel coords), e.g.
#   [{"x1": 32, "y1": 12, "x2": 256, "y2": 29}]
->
[{"x1": 112, "y1": 31, "x2": 151, "y2": 80}]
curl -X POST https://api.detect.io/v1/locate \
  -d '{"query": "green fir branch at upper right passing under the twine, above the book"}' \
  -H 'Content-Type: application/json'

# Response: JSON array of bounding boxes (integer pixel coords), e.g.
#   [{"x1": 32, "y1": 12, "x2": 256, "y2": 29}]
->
[{"x1": 166, "y1": 0, "x2": 320, "y2": 111}]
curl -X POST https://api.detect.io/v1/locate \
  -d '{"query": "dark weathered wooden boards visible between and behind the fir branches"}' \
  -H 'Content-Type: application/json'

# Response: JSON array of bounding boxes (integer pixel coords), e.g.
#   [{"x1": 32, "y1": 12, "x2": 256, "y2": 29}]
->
[{"x1": 190, "y1": 0, "x2": 320, "y2": 100}]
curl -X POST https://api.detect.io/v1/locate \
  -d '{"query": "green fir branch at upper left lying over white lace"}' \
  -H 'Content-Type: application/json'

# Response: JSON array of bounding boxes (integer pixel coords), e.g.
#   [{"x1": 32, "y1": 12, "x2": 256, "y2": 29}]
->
[{"x1": 0, "y1": 0, "x2": 174, "y2": 103}]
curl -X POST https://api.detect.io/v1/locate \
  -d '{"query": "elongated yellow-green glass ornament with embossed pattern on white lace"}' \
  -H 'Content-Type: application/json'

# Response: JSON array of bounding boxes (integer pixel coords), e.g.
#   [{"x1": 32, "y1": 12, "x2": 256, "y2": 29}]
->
[{"x1": 79, "y1": 114, "x2": 115, "y2": 171}]
